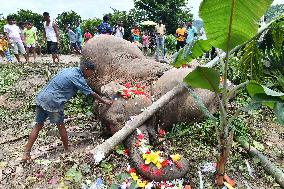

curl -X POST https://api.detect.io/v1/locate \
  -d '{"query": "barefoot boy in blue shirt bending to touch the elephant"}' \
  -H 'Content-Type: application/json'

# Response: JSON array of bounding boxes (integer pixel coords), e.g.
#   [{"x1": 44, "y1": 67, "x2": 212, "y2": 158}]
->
[{"x1": 22, "y1": 60, "x2": 112, "y2": 161}]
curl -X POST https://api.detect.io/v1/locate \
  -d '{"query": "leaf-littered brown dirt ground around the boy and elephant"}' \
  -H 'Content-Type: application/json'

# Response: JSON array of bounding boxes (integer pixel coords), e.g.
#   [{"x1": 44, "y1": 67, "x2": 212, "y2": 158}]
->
[{"x1": 0, "y1": 55, "x2": 284, "y2": 189}]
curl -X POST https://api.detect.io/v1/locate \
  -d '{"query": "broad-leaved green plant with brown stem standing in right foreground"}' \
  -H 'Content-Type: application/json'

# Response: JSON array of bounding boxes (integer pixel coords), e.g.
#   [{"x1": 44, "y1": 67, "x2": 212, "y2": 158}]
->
[{"x1": 174, "y1": 0, "x2": 284, "y2": 185}]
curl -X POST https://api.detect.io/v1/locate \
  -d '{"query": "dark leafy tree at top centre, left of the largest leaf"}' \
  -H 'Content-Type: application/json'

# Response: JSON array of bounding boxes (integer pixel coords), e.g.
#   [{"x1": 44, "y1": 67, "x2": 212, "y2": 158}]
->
[{"x1": 134, "y1": 0, "x2": 192, "y2": 33}]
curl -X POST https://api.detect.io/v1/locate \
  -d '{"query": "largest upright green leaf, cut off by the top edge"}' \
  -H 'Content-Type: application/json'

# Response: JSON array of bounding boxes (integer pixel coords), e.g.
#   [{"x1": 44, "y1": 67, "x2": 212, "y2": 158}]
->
[{"x1": 199, "y1": 0, "x2": 272, "y2": 51}]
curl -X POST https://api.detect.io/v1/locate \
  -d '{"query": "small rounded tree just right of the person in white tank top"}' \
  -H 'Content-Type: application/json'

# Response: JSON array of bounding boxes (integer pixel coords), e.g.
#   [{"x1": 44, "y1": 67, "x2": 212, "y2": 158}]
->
[{"x1": 56, "y1": 10, "x2": 82, "y2": 30}]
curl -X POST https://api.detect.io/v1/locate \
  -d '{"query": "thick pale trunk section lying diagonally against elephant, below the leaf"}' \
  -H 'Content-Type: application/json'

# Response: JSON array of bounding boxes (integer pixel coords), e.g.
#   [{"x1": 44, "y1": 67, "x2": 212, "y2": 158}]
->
[{"x1": 90, "y1": 85, "x2": 186, "y2": 163}]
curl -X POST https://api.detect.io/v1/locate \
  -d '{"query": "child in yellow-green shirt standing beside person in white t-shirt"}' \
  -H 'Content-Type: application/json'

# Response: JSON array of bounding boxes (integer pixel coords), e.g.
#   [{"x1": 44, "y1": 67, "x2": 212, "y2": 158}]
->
[{"x1": 23, "y1": 22, "x2": 37, "y2": 62}]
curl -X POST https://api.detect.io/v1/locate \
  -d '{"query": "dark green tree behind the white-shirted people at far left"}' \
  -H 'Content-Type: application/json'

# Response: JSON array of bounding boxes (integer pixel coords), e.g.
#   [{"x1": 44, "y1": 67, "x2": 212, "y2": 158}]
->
[{"x1": 10, "y1": 9, "x2": 43, "y2": 31}]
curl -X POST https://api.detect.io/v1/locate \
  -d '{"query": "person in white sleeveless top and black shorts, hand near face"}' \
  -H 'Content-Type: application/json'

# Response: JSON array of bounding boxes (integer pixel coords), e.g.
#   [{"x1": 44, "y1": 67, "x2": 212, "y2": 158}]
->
[{"x1": 43, "y1": 12, "x2": 59, "y2": 63}]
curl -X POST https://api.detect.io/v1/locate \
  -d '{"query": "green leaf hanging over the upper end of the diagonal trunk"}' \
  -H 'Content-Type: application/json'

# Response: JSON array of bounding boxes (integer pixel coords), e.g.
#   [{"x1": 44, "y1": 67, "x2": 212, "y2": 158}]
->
[{"x1": 183, "y1": 67, "x2": 220, "y2": 94}]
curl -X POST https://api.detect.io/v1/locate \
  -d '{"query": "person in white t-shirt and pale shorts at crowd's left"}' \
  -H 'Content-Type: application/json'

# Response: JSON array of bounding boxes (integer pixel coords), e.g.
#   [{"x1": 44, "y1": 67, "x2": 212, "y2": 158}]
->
[{"x1": 4, "y1": 16, "x2": 28, "y2": 62}]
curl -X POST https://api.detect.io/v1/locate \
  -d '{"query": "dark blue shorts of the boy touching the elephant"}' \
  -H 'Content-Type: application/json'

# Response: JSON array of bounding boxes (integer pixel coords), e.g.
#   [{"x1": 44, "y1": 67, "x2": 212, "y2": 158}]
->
[{"x1": 35, "y1": 105, "x2": 64, "y2": 125}]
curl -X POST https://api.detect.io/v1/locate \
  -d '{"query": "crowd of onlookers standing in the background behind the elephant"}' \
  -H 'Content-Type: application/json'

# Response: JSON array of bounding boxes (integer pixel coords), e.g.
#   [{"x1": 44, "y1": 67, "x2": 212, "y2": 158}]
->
[{"x1": 0, "y1": 12, "x2": 204, "y2": 63}]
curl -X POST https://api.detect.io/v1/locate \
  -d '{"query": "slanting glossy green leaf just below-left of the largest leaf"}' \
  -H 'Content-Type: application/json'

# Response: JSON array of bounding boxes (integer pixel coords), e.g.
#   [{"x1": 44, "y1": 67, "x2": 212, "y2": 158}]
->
[{"x1": 172, "y1": 40, "x2": 212, "y2": 68}]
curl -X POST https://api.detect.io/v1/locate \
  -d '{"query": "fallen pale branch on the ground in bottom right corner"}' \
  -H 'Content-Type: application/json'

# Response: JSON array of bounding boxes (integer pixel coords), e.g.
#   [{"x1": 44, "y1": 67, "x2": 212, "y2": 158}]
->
[{"x1": 237, "y1": 138, "x2": 284, "y2": 188}]
